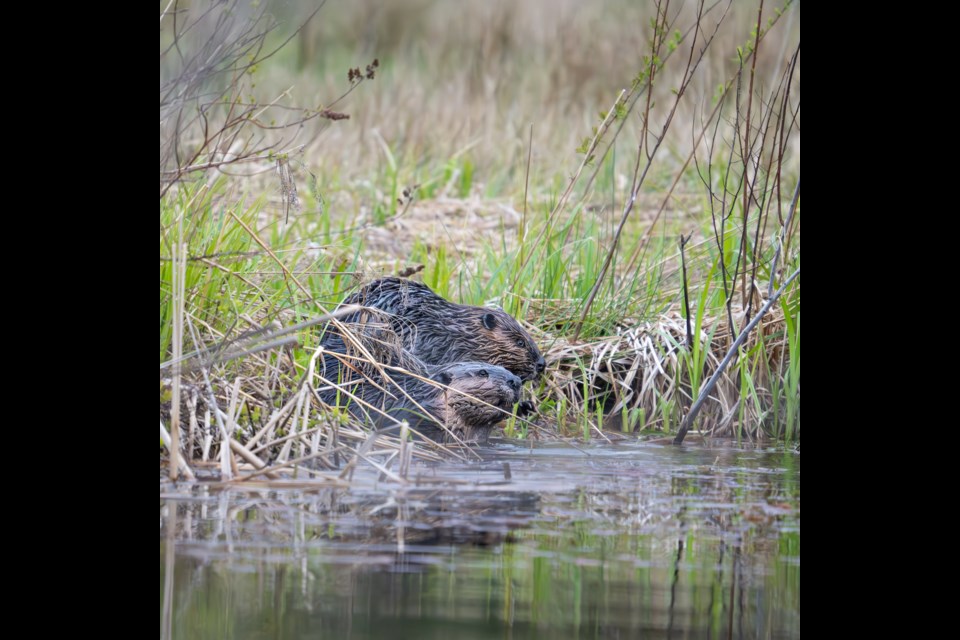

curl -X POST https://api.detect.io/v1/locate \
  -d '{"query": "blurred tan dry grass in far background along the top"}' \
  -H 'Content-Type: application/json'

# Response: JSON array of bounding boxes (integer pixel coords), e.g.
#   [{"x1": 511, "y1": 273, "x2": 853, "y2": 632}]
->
[{"x1": 212, "y1": 0, "x2": 800, "y2": 197}]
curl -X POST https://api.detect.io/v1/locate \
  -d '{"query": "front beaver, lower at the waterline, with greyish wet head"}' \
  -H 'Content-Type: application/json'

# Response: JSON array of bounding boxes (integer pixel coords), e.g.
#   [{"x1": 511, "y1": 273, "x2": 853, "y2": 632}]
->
[{"x1": 321, "y1": 362, "x2": 522, "y2": 442}]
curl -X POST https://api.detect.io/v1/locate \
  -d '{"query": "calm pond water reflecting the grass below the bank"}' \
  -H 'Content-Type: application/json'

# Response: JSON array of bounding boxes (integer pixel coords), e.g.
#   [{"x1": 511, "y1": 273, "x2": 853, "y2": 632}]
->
[{"x1": 160, "y1": 443, "x2": 800, "y2": 640}]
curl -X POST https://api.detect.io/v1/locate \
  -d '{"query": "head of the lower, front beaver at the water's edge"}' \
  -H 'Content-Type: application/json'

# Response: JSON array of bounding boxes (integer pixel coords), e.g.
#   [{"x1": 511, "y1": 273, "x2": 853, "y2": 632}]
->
[{"x1": 430, "y1": 362, "x2": 522, "y2": 442}]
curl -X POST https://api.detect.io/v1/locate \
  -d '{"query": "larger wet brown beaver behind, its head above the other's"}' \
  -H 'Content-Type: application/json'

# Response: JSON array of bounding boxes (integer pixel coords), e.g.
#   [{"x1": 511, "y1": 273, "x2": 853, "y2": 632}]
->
[{"x1": 344, "y1": 278, "x2": 546, "y2": 380}]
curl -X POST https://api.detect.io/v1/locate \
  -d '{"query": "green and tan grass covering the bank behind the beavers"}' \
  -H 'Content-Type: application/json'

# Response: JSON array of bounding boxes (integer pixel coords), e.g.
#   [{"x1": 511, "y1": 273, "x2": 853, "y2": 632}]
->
[{"x1": 160, "y1": 0, "x2": 800, "y2": 480}]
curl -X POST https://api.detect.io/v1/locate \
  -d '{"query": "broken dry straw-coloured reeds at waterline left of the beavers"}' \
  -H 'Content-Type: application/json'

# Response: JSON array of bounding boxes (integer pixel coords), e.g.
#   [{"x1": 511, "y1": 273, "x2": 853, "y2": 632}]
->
[{"x1": 160, "y1": 306, "x2": 548, "y2": 482}]
